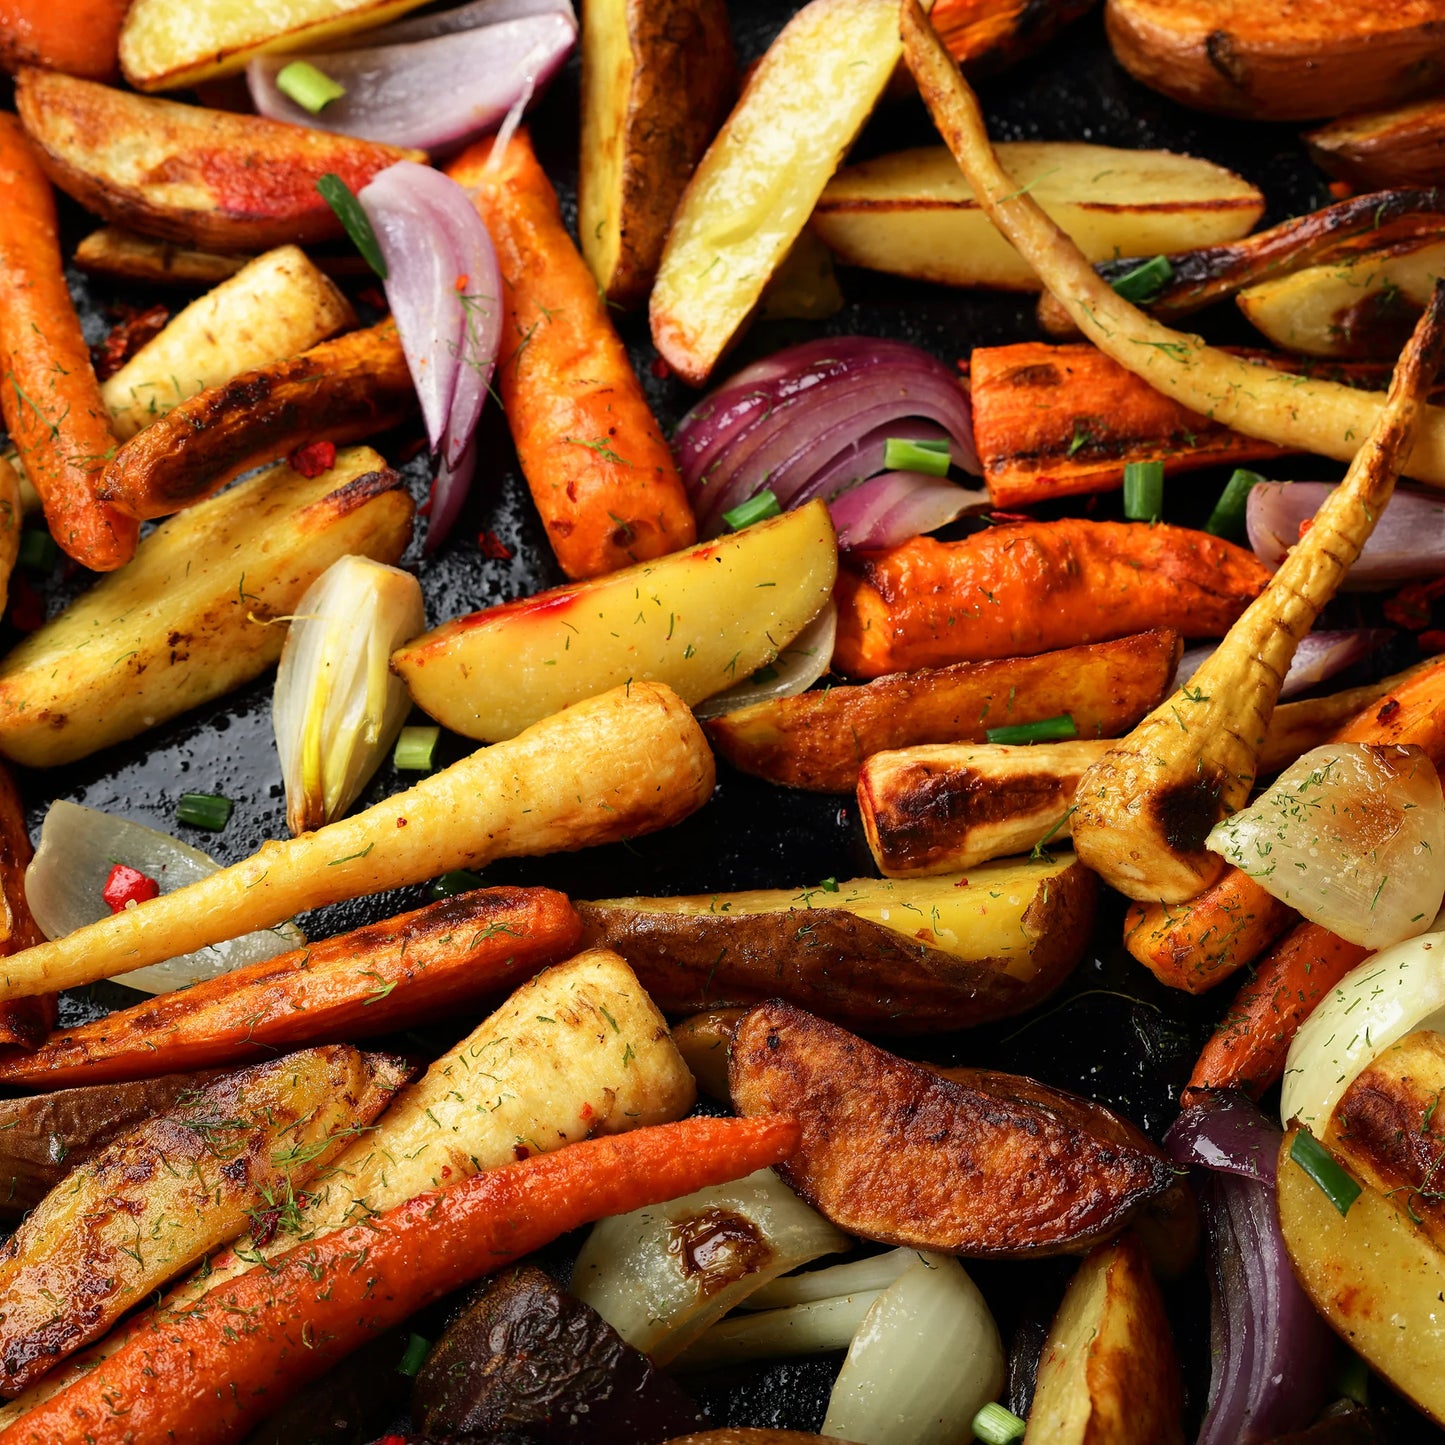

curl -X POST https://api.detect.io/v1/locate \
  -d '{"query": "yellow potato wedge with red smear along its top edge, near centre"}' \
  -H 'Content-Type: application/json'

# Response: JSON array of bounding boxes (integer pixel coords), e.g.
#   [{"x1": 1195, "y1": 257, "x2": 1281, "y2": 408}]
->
[{"x1": 392, "y1": 501, "x2": 838, "y2": 743}]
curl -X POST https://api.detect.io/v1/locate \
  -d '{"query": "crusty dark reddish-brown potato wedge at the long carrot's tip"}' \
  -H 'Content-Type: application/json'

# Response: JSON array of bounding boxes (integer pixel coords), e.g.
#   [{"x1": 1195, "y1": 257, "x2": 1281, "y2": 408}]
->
[{"x1": 728, "y1": 1000, "x2": 1173, "y2": 1259}]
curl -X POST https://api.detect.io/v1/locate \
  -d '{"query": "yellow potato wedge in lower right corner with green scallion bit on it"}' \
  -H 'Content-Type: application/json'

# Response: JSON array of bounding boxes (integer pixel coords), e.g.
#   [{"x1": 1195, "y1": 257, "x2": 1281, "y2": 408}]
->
[{"x1": 1277, "y1": 1129, "x2": 1445, "y2": 1425}]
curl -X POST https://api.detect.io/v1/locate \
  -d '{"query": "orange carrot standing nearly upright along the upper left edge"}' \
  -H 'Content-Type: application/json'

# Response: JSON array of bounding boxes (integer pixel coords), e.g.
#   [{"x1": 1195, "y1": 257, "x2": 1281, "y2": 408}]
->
[{"x1": 0, "y1": 114, "x2": 137, "y2": 572}]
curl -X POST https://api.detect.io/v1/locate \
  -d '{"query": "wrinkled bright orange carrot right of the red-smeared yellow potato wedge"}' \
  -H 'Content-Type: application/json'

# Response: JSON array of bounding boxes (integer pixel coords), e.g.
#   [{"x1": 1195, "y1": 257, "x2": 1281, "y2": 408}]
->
[{"x1": 834, "y1": 517, "x2": 1269, "y2": 678}]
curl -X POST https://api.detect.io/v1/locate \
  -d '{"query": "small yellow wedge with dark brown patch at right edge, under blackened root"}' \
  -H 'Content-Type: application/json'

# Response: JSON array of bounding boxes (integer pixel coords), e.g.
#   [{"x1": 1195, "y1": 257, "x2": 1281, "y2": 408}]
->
[{"x1": 1234, "y1": 241, "x2": 1445, "y2": 360}]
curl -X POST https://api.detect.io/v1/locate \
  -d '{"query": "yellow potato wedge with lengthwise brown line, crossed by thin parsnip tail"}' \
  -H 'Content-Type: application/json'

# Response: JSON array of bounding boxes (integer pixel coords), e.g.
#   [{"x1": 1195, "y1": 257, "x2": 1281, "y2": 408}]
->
[{"x1": 811, "y1": 140, "x2": 1264, "y2": 290}]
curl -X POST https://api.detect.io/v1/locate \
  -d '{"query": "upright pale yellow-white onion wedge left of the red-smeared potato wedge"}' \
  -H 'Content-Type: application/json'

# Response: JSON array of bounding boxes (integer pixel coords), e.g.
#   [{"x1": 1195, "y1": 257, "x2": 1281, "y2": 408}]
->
[{"x1": 272, "y1": 556, "x2": 426, "y2": 834}]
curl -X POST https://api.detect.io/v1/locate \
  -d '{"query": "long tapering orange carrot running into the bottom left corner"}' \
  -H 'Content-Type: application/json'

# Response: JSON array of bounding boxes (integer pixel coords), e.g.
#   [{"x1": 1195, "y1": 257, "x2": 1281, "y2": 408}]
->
[{"x1": 0, "y1": 1116, "x2": 799, "y2": 1445}]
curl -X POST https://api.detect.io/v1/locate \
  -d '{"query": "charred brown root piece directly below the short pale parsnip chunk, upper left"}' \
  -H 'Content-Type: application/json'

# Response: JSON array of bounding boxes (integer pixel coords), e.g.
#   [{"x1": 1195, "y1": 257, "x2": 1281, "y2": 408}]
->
[{"x1": 98, "y1": 321, "x2": 416, "y2": 519}]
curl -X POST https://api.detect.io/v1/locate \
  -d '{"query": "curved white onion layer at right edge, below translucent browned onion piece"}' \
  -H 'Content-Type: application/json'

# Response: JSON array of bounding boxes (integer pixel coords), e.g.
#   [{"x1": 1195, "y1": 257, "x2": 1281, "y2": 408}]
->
[{"x1": 1279, "y1": 919, "x2": 1445, "y2": 1139}]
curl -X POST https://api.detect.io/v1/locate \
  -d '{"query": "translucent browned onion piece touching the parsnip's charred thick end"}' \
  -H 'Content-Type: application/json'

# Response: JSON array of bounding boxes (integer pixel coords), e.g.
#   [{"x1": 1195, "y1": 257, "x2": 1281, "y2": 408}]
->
[{"x1": 1205, "y1": 743, "x2": 1445, "y2": 948}]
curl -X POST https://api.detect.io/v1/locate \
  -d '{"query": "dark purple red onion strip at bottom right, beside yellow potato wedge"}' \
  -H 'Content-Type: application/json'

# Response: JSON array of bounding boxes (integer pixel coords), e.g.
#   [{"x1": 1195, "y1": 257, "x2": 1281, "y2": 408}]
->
[{"x1": 1165, "y1": 1097, "x2": 1334, "y2": 1445}]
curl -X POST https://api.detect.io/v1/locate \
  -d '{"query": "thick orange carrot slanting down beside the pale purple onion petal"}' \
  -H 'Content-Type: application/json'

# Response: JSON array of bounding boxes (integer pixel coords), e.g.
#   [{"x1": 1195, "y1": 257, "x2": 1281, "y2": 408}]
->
[{"x1": 447, "y1": 129, "x2": 696, "y2": 579}]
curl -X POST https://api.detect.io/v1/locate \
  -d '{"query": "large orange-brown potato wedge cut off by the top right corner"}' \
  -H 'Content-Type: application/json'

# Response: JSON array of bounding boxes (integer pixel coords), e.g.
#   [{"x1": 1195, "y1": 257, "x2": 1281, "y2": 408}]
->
[{"x1": 1104, "y1": 0, "x2": 1445, "y2": 120}]
